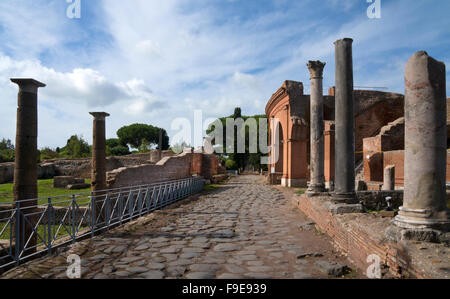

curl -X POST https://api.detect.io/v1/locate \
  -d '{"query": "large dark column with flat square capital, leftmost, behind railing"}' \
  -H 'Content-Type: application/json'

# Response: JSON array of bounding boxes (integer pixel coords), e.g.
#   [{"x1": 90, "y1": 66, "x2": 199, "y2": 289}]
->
[{"x1": 11, "y1": 79, "x2": 45, "y2": 254}]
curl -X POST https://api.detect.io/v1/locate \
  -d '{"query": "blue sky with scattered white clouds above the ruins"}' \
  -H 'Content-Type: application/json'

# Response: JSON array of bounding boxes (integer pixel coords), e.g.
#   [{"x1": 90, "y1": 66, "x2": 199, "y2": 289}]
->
[{"x1": 0, "y1": 0, "x2": 450, "y2": 147}]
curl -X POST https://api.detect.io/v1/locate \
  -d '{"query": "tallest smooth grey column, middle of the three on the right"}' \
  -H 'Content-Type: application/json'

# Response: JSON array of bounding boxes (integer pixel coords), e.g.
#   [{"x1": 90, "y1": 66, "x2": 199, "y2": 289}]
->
[{"x1": 333, "y1": 38, "x2": 356, "y2": 204}]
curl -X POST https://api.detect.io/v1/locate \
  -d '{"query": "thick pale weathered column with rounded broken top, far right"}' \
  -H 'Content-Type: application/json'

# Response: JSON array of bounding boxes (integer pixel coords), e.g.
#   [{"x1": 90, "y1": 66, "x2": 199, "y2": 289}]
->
[{"x1": 395, "y1": 51, "x2": 450, "y2": 235}]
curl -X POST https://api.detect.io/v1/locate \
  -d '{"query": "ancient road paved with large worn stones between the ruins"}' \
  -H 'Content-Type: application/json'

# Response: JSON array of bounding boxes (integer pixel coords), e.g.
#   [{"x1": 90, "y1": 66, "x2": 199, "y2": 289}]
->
[{"x1": 3, "y1": 176, "x2": 358, "y2": 279}]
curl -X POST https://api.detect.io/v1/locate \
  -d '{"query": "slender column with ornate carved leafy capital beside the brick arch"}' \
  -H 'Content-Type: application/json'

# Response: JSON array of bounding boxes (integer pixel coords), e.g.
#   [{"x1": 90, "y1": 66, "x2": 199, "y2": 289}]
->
[{"x1": 307, "y1": 61, "x2": 326, "y2": 195}]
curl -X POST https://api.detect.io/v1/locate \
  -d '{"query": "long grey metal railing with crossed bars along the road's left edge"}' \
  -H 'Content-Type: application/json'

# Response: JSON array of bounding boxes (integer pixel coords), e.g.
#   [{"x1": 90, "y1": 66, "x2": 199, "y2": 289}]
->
[{"x1": 0, "y1": 178, "x2": 204, "y2": 269}]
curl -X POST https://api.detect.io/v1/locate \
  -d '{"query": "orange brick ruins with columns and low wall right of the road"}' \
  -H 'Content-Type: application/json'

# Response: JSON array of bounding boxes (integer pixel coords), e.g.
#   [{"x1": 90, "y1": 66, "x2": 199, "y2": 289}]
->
[{"x1": 266, "y1": 39, "x2": 450, "y2": 278}]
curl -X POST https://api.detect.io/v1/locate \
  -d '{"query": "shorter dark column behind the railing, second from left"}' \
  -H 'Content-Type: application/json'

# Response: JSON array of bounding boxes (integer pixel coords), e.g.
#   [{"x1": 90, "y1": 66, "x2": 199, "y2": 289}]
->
[{"x1": 90, "y1": 112, "x2": 109, "y2": 225}]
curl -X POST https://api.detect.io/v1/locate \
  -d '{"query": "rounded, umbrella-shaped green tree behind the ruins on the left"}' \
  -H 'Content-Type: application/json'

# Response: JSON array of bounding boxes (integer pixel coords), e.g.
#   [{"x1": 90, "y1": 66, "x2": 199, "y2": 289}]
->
[{"x1": 117, "y1": 124, "x2": 169, "y2": 150}]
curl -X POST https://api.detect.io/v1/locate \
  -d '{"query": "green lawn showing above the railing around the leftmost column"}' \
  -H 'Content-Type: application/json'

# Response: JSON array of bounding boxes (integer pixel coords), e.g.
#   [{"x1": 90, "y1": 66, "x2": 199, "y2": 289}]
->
[{"x1": 0, "y1": 179, "x2": 91, "y2": 204}]
